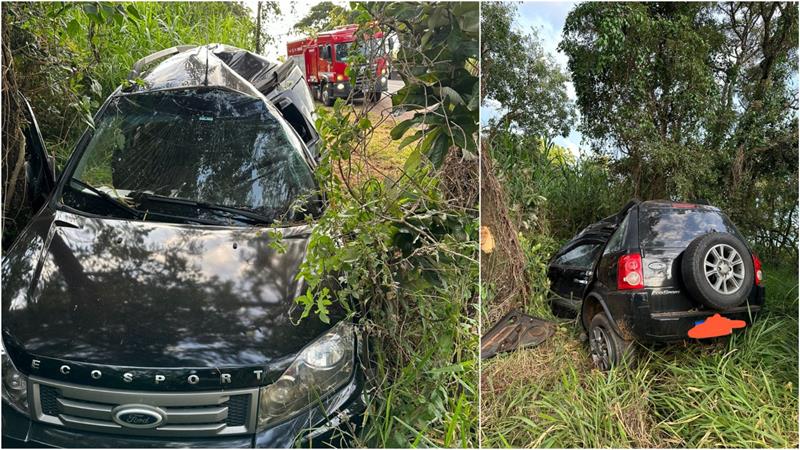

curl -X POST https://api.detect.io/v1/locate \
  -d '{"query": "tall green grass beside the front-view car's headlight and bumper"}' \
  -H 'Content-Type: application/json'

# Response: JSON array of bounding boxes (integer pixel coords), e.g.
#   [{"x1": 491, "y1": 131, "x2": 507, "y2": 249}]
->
[{"x1": 357, "y1": 264, "x2": 478, "y2": 448}]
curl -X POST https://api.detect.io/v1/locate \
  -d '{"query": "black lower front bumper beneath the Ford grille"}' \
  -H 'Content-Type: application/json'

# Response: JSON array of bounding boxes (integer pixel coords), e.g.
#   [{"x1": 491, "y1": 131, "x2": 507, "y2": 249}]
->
[{"x1": 2, "y1": 370, "x2": 366, "y2": 448}]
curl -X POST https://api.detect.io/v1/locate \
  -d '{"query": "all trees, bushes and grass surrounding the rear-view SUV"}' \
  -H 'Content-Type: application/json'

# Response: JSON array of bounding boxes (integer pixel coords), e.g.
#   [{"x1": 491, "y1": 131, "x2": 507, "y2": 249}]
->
[{"x1": 481, "y1": 3, "x2": 798, "y2": 448}]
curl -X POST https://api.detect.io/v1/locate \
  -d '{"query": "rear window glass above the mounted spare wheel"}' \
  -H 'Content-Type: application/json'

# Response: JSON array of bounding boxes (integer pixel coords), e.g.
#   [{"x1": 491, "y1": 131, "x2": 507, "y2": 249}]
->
[{"x1": 639, "y1": 208, "x2": 739, "y2": 248}]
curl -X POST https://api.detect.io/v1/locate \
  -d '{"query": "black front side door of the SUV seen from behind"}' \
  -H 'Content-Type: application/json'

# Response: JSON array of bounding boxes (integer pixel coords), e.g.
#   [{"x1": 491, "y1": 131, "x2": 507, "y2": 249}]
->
[{"x1": 548, "y1": 238, "x2": 605, "y2": 300}]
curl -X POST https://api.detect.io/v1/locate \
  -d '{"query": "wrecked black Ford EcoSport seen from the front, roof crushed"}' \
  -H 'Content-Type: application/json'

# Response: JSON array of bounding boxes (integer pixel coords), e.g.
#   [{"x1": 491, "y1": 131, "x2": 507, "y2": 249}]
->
[{"x1": 2, "y1": 45, "x2": 365, "y2": 448}]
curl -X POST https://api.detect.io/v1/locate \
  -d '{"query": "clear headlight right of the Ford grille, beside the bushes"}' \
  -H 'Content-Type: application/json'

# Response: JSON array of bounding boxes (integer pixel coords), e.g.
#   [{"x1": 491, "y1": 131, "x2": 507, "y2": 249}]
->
[{"x1": 258, "y1": 321, "x2": 355, "y2": 430}]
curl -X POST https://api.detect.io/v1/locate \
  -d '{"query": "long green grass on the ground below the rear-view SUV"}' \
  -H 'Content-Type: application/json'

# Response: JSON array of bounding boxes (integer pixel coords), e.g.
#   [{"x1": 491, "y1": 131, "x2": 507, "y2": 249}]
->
[{"x1": 481, "y1": 267, "x2": 798, "y2": 448}]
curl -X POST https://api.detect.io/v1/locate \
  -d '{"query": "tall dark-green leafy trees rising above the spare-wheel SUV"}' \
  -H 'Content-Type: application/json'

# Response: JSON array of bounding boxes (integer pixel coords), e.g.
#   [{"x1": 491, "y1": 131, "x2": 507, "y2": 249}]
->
[{"x1": 560, "y1": 2, "x2": 798, "y2": 264}]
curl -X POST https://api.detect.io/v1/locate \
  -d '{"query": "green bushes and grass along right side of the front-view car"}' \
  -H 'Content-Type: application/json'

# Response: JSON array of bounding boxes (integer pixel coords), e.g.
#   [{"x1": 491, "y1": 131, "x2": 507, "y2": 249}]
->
[{"x1": 298, "y1": 3, "x2": 478, "y2": 447}]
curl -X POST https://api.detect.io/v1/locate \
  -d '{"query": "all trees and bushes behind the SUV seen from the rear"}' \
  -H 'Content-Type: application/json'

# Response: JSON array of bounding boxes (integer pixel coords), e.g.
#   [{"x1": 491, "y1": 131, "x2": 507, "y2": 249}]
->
[{"x1": 483, "y1": 3, "x2": 798, "y2": 261}]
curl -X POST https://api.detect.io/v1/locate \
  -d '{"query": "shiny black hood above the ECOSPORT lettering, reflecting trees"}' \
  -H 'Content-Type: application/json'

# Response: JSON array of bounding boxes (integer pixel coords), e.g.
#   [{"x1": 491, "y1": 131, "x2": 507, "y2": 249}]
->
[{"x1": 2, "y1": 209, "x2": 339, "y2": 386}]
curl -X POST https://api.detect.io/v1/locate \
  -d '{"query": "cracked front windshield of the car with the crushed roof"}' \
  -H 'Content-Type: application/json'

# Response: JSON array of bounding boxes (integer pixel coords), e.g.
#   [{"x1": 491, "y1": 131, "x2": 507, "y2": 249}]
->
[{"x1": 65, "y1": 89, "x2": 316, "y2": 222}]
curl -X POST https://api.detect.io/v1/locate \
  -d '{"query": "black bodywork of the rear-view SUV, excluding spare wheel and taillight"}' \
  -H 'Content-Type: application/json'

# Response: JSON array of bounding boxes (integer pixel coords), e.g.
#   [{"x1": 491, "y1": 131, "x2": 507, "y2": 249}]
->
[{"x1": 548, "y1": 201, "x2": 765, "y2": 342}]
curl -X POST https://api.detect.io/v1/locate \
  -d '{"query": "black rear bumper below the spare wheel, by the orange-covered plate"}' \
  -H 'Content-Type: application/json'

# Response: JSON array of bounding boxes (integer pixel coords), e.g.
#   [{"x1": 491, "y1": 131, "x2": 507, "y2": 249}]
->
[{"x1": 614, "y1": 286, "x2": 765, "y2": 342}]
